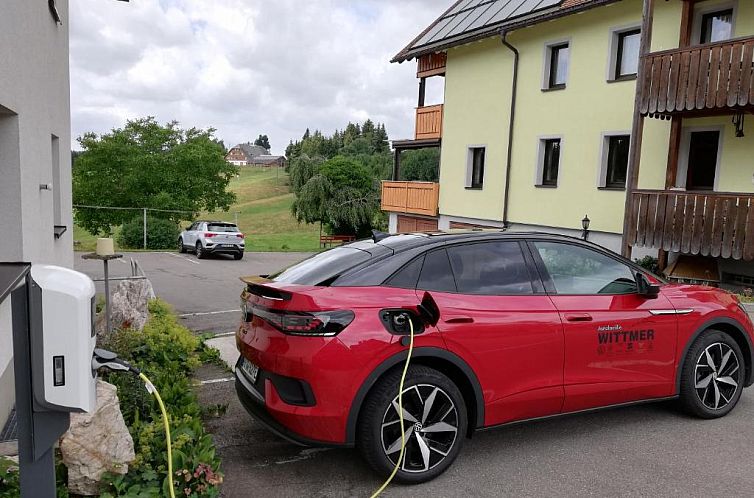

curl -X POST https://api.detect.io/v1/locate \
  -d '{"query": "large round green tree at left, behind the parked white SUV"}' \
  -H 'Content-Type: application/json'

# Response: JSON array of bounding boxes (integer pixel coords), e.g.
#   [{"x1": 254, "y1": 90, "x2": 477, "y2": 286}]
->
[{"x1": 73, "y1": 117, "x2": 238, "y2": 235}]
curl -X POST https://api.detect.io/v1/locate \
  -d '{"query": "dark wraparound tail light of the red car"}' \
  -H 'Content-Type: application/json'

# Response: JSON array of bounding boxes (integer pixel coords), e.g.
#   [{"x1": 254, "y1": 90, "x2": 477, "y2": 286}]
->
[{"x1": 244, "y1": 306, "x2": 354, "y2": 337}]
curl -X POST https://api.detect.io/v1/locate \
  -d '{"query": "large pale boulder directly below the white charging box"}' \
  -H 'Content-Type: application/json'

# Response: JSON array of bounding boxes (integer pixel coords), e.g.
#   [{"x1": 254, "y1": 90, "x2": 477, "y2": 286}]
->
[{"x1": 60, "y1": 380, "x2": 136, "y2": 496}]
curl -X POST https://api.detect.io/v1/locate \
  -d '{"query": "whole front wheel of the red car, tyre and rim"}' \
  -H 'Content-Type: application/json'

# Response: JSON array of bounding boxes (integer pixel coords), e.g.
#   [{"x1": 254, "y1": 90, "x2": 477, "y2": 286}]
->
[{"x1": 681, "y1": 330, "x2": 746, "y2": 419}]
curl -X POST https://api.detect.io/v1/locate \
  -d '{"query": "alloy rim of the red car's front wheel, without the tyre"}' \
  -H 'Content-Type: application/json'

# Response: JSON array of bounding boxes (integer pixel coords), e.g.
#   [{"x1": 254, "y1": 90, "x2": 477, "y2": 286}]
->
[{"x1": 695, "y1": 342, "x2": 741, "y2": 410}]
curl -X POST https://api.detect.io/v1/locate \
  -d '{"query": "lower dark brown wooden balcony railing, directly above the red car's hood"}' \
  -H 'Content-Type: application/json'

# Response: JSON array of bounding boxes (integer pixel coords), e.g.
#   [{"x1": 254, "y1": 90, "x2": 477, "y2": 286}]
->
[{"x1": 628, "y1": 190, "x2": 754, "y2": 261}]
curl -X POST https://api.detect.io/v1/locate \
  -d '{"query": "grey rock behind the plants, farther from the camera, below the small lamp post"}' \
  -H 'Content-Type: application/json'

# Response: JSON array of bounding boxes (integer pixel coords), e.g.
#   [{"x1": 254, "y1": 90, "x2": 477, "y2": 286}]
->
[{"x1": 97, "y1": 278, "x2": 155, "y2": 334}]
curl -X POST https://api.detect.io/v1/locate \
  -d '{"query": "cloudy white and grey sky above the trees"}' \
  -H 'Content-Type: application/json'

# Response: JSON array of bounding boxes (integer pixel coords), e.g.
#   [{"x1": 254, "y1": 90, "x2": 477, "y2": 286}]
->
[{"x1": 70, "y1": 0, "x2": 451, "y2": 153}]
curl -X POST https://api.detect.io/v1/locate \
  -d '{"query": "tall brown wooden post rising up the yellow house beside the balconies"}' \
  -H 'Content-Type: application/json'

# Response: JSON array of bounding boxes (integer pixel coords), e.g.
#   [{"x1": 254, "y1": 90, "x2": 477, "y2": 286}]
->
[{"x1": 622, "y1": 0, "x2": 655, "y2": 258}]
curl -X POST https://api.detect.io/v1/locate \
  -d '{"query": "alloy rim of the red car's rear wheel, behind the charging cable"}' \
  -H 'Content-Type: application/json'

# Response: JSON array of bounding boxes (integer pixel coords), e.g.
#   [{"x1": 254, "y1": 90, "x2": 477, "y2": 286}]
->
[{"x1": 381, "y1": 384, "x2": 458, "y2": 473}]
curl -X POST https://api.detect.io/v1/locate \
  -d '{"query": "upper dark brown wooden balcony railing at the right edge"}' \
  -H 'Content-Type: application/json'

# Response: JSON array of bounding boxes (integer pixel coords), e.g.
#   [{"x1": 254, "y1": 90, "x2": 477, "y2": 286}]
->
[{"x1": 639, "y1": 37, "x2": 754, "y2": 116}]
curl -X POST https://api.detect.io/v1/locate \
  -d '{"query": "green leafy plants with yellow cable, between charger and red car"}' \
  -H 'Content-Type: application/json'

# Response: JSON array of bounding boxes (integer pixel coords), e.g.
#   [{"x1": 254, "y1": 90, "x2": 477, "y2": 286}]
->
[{"x1": 101, "y1": 300, "x2": 222, "y2": 498}]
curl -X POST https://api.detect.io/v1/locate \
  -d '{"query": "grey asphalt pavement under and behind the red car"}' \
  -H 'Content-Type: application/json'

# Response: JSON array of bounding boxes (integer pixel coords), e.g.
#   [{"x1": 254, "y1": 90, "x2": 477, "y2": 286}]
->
[{"x1": 77, "y1": 254, "x2": 754, "y2": 498}]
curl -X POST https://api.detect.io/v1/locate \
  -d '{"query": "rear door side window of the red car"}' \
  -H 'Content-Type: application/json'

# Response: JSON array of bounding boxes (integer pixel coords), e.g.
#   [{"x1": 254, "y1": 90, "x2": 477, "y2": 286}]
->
[{"x1": 448, "y1": 241, "x2": 534, "y2": 296}]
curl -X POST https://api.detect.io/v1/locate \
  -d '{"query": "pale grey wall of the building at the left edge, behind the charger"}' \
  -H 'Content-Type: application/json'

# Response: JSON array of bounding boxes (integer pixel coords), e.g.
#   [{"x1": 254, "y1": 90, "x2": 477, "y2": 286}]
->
[{"x1": 0, "y1": 0, "x2": 73, "y2": 427}]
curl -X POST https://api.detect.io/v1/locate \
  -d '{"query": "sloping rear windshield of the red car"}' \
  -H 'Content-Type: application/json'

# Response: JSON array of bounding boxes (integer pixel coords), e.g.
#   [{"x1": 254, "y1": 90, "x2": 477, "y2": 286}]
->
[{"x1": 270, "y1": 247, "x2": 372, "y2": 285}]
